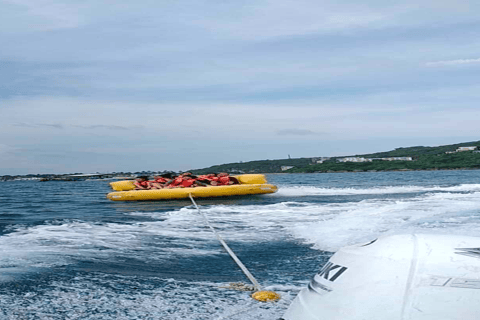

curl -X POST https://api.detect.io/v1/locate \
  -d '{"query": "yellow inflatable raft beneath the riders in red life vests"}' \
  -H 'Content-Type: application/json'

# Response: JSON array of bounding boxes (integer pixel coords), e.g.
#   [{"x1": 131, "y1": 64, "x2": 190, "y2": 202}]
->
[{"x1": 107, "y1": 174, "x2": 277, "y2": 201}]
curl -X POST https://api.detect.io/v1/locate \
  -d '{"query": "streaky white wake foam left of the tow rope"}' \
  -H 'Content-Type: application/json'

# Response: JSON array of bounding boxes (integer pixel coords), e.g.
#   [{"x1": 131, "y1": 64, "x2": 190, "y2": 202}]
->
[{"x1": 0, "y1": 216, "x2": 221, "y2": 280}]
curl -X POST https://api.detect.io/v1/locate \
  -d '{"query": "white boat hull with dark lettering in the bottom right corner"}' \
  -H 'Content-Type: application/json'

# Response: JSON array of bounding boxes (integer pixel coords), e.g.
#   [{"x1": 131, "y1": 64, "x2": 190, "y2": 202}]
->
[{"x1": 284, "y1": 235, "x2": 480, "y2": 320}]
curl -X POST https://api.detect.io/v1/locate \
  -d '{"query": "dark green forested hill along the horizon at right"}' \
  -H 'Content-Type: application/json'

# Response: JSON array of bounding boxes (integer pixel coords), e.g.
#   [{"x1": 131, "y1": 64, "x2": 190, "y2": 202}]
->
[{"x1": 191, "y1": 141, "x2": 480, "y2": 174}]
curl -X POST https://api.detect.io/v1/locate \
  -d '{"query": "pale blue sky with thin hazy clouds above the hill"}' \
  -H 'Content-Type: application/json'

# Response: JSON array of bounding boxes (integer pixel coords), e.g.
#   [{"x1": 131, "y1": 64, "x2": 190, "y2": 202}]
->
[{"x1": 0, "y1": 0, "x2": 480, "y2": 175}]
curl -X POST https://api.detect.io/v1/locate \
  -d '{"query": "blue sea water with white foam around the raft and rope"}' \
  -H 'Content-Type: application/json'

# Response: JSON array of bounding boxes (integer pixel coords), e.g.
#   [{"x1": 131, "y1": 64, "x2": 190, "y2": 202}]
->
[{"x1": 0, "y1": 171, "x2": 480, "y2": 320}]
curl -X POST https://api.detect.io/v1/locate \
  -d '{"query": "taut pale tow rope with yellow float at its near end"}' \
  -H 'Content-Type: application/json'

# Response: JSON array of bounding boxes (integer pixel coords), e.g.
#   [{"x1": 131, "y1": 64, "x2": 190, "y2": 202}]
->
[{"x1": 188, "y1": 193, "x2": 280, "y2": 302}]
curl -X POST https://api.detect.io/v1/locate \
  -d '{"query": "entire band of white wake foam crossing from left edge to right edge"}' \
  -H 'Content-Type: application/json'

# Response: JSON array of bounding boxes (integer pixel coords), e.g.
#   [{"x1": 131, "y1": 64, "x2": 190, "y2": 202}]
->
[{"x1": 0, "y1": 185, "x2": 480, "y2": 275}]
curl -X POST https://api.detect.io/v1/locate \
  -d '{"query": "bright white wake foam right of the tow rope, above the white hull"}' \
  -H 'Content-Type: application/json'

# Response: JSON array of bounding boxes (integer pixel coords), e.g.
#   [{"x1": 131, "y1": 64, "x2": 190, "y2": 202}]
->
[{"x1": 127, "y1": 188, "x2": 480, "y2": 251}]
